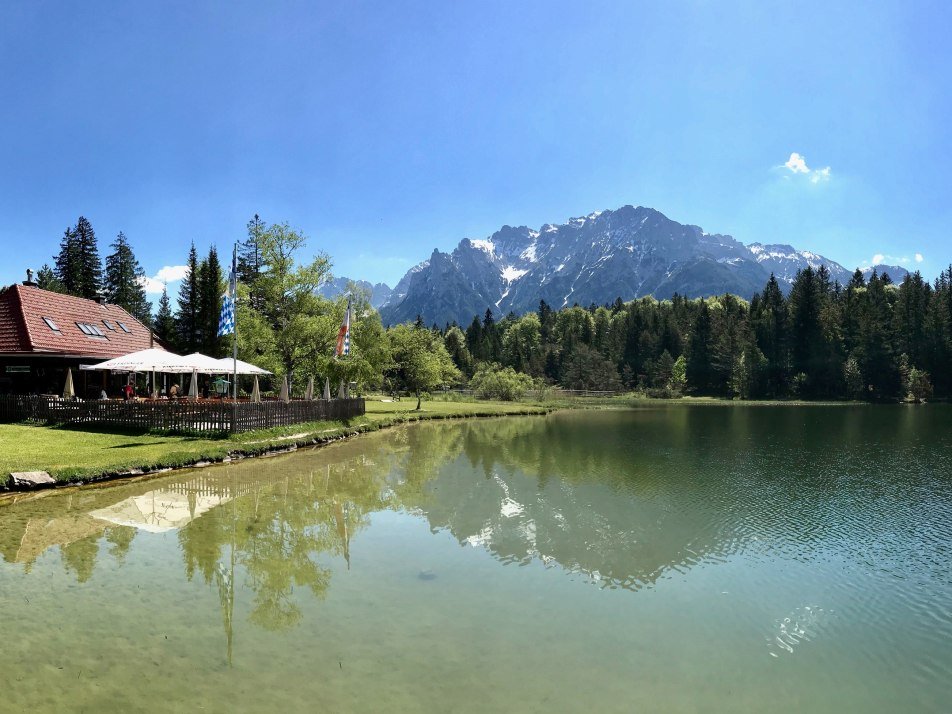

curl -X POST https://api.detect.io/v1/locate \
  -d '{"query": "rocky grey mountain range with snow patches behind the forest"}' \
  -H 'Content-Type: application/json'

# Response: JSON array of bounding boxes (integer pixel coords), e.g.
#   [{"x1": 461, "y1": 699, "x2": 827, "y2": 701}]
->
[{"x1": 326, "y1": 206, "x2": 907, "y2": 325}]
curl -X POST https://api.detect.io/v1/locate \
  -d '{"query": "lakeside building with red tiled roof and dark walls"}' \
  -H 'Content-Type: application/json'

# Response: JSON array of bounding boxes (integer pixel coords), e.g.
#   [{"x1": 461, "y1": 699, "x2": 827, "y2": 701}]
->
[{"x1": 0, "y1": 281, "x2": 162, "y2": 397}]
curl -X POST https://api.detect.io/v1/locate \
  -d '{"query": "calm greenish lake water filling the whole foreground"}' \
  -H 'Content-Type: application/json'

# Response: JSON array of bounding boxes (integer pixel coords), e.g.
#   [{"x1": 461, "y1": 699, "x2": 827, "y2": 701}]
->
[{"x1": 0, "y1": 405, "x2": 952, "y2": 712}]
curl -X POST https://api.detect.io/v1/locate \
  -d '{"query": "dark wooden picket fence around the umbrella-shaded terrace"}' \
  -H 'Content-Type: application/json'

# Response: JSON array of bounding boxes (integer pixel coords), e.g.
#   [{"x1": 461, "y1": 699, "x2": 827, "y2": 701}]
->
[{"x1": 0, "y1": 395, "x2": 364, "y2": 433}]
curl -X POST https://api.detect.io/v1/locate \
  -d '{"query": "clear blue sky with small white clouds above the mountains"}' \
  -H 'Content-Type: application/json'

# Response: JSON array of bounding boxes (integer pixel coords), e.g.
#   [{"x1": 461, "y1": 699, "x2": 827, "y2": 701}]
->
[{"x1": 0, "y1": 1, "x2": 952, "y2": 298}]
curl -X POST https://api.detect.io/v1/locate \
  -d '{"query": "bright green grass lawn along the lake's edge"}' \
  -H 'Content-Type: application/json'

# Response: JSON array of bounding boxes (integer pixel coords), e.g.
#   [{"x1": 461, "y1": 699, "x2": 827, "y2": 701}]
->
[{"x1": 0, "y1": 399, "x2": 546, "y2": 486}]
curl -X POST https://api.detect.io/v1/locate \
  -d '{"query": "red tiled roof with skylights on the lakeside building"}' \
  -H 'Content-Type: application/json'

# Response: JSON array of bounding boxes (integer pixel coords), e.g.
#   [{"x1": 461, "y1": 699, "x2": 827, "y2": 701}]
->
[{"x1": 0, "y1": 285, "x2": 162, "y2": 359}]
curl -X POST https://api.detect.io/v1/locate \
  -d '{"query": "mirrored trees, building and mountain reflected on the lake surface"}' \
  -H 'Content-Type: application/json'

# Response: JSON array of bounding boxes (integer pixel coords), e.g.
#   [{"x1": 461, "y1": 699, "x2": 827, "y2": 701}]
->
[{"x1": 0, "y1": 408, "x2": 952, "y2": 661}]
